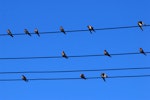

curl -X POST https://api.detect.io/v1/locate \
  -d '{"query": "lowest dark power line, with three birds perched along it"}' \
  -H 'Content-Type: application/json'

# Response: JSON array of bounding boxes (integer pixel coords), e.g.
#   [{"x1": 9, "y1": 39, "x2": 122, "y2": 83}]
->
[{"x1": 0, "y1": 74, "x2": 150, "y2": 82}]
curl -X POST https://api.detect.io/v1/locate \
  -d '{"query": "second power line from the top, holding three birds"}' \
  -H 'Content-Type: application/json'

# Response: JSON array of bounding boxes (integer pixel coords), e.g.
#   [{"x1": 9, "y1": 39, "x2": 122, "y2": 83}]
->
[{"x1": 0, "y1": 52, "x2": 150, "y2": 60}]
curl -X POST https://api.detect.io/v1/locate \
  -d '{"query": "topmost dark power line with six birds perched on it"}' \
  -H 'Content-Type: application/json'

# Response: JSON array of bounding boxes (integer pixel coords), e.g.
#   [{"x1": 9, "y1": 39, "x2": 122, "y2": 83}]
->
[{"x1": 0, "y1": 25, "x2": 150, "y2": 36}]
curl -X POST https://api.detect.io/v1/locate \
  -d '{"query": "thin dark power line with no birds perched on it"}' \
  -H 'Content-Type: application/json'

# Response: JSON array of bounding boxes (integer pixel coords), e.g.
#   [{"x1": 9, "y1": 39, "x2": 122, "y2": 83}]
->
[{"x1": 0, "y1": 67, "x2": 150, "y2": 74}]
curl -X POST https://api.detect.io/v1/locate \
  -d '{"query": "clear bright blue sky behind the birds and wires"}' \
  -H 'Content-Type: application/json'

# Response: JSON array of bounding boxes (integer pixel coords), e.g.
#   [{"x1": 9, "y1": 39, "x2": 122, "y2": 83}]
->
[{"x1": 0, "y1": 0, "x2": 150, "y2": 100}]
